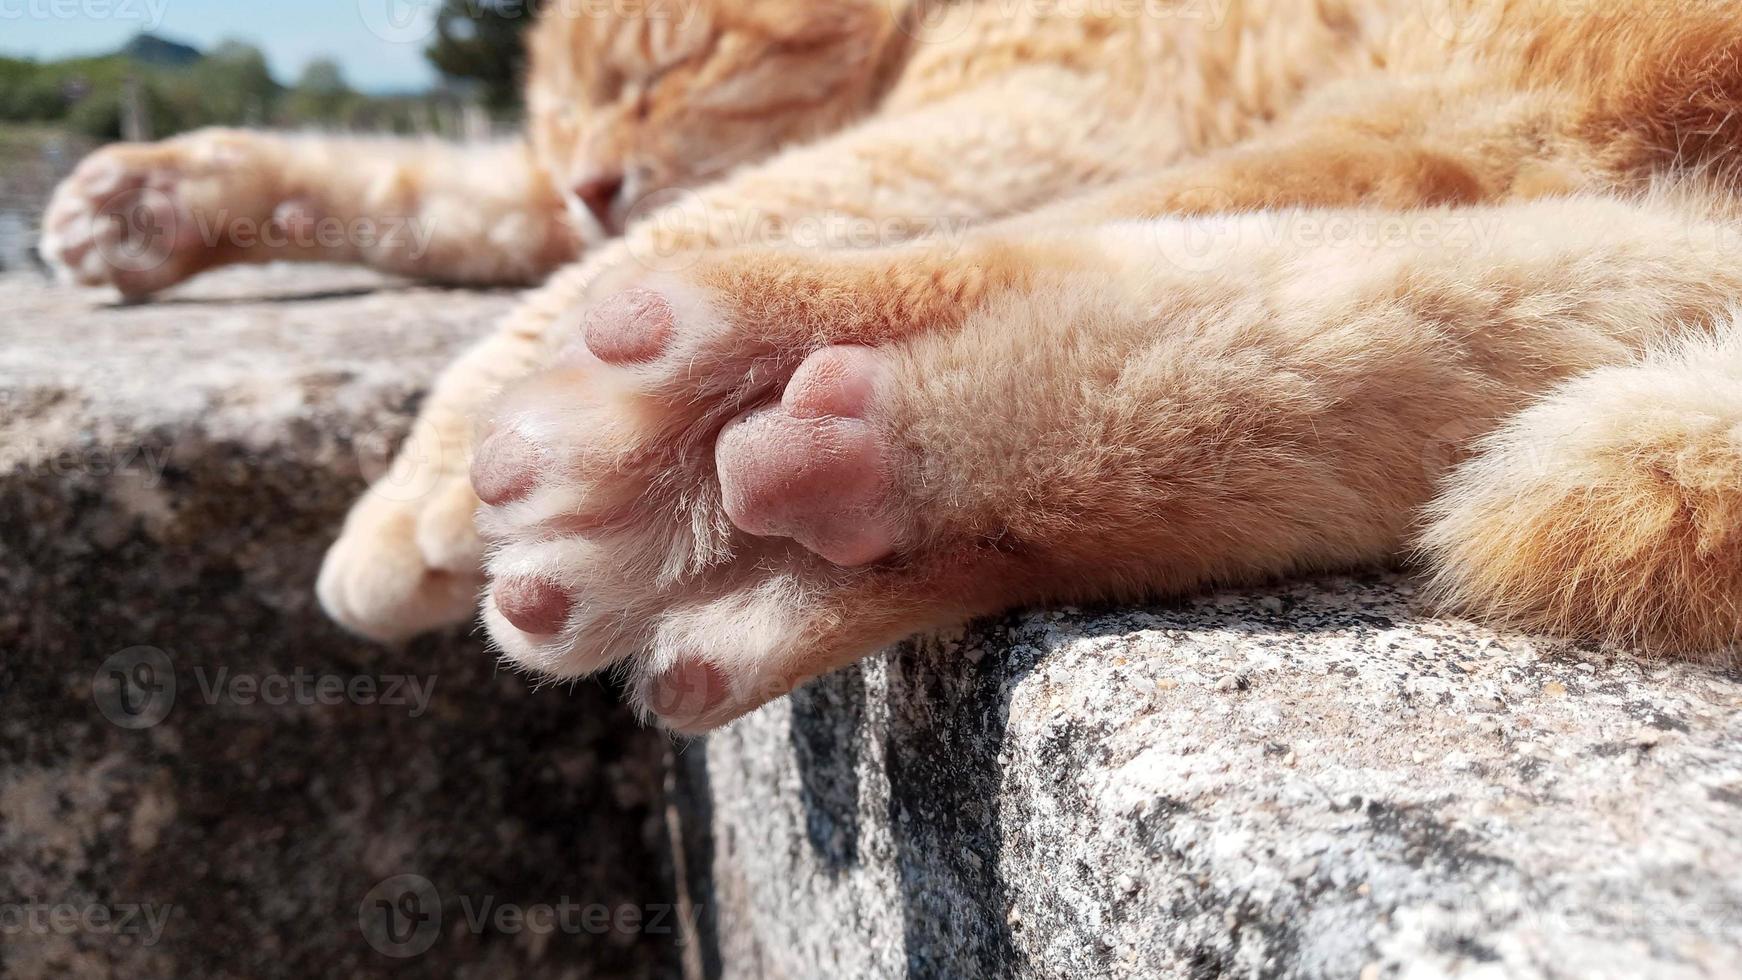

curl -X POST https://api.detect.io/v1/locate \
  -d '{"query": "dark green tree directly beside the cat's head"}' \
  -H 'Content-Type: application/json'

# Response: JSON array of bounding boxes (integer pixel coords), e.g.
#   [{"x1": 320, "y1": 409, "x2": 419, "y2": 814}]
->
[{"x1": 423, "y1": 0, "x2": 533, "y2": 111}]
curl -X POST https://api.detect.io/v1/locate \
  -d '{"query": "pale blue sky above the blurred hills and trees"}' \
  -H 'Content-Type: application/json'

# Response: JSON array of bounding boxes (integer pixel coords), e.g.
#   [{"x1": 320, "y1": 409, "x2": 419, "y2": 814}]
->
[{"x1": 0, "y1": 0, "x2": 439, "y2": 91}]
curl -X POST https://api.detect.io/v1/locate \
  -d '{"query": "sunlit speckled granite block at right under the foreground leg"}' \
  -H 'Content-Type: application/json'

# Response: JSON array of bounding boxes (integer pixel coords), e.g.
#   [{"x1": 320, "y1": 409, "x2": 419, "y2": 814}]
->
[{"x1": 686, "y1": 576, "x2": 1742, "y2": 980}]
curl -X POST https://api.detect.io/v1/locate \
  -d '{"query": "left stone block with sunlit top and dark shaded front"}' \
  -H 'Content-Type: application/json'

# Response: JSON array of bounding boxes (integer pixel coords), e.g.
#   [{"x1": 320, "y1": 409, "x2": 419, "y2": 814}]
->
[{"x1": 0, "y1": 268, "x2": 678, "y2": 978}]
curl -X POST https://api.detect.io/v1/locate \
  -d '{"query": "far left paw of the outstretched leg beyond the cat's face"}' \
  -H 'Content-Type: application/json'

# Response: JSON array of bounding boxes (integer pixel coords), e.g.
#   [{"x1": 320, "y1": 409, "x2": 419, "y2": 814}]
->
[{"x1": 38, "y1": 131, "x2": 275, "y2": 298}]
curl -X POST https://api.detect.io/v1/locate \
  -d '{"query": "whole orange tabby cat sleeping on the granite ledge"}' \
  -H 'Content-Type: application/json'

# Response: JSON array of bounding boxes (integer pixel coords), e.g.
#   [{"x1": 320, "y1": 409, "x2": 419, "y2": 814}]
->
[{"x1": 45, "y1": 0, "x2": 1742, "y2": 731}]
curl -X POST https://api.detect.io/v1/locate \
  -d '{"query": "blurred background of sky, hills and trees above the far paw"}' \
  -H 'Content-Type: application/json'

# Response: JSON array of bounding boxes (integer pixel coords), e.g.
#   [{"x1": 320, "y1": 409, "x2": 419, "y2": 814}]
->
[{"x1": 0, "y1": 0, "x2": 533, "y2": 270}]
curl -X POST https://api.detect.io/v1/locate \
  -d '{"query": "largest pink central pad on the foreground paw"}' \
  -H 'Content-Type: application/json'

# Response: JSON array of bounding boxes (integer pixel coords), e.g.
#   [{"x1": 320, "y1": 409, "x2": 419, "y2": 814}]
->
[{"x1": 714, "y1": 346, "x2": 897, "y2": 566}]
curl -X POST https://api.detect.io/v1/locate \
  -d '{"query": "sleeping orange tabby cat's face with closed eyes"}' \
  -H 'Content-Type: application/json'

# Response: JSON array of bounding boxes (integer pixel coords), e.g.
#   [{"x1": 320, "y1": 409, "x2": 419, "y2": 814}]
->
[{"x1": 528, "y1": 0, "x2": 890, "y2": 238}]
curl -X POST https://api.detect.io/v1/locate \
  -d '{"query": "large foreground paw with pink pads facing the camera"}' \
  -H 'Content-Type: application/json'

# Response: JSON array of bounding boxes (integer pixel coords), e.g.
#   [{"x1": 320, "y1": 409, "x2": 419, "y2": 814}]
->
[{"x1": 472, "y1": 254, "x2": 1017, "y2": 733}]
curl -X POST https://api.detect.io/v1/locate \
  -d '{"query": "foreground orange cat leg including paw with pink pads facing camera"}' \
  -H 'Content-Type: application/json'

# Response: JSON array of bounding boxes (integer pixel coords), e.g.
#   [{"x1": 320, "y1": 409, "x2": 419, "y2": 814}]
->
[{"x1": 474, "y1": 200, "x2": 1742, "y2": 731}]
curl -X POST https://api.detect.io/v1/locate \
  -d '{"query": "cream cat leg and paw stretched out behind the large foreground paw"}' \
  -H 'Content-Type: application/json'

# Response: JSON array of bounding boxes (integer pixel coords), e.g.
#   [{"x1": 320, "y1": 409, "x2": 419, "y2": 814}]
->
[{"x1": 319, "y1": 78, "x2": 1184, "y2": 639}]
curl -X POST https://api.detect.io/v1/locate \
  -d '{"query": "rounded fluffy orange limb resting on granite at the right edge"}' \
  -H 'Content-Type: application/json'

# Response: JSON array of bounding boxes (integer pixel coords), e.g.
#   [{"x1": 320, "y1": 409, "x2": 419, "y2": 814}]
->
[{"x1": 1421, "y1": 326, "x2": 1742, "y2": 658}]
